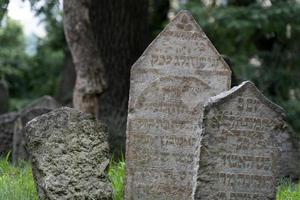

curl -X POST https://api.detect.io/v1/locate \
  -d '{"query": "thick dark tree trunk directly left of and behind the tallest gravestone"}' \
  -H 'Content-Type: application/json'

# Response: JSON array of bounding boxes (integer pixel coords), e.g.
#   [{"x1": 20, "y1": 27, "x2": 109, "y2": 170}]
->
[{"x1": 91, "y1": 0, "x2": 149, "y2": 152}]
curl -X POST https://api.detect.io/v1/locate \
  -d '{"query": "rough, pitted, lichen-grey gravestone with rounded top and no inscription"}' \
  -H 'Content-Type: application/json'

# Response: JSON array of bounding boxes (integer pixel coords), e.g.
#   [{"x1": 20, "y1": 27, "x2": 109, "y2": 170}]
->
[{"x1": 25, "y1": 108, "x2": 112, "y2": 200}]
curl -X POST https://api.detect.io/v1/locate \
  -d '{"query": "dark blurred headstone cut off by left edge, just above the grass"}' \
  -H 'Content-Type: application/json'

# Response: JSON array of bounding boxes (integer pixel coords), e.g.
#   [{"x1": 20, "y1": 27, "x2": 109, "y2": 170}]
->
[{"x1": 0, "y1": 112, "x2": 18, "y2": 156}]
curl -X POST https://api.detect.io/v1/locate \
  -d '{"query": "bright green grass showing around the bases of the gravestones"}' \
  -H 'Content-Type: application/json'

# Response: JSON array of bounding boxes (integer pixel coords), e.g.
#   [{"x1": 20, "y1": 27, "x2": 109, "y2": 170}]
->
[{"x1": 0, "y1": 156, "x2": 300, "y2": 200}]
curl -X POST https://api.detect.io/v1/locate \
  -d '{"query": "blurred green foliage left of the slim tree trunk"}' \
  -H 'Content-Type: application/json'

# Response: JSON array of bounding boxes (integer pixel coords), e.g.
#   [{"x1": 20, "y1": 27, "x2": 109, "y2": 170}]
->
[{"x1": 0, "y1": 0, "x2": 68, "y2": 110}]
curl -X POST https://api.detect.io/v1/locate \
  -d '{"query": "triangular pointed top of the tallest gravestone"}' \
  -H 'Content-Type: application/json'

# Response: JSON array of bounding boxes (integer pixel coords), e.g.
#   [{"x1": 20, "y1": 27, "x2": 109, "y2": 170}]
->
[{"x1": 132, "y1": 10, "x2": 231, "y2": 74}]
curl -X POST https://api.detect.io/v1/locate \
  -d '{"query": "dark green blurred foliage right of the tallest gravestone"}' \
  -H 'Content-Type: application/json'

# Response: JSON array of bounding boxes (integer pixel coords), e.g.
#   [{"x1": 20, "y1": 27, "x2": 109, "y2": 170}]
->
[{"x1": 187, "y1": 0, "x2": 300, "y2": 132}]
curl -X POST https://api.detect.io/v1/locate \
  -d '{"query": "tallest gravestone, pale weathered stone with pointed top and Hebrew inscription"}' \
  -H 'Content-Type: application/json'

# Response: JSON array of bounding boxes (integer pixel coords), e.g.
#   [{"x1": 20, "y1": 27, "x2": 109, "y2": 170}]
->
[{"x1": 125, "y1": 11, "x2": 231, "y2": 200}]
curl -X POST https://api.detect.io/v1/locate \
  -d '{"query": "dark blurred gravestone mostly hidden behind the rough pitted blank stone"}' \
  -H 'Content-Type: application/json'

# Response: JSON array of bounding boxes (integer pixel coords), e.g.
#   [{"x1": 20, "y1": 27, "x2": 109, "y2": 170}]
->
[{"x1": 12, "y1": 96, "x2": 61, "y2": 164}]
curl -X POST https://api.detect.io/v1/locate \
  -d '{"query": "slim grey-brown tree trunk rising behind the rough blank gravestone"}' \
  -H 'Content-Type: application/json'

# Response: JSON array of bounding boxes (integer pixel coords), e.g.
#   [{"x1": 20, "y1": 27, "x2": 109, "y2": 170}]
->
[{"x1": 63, "y1": 0, "x2": 106, "y2": 116}]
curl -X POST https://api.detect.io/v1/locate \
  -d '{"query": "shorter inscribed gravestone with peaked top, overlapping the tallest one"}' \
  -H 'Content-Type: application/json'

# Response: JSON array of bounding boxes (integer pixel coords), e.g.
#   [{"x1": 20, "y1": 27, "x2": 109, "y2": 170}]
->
[{"x1": 195, "y1": 82, "x2": 285, "y2": 200}]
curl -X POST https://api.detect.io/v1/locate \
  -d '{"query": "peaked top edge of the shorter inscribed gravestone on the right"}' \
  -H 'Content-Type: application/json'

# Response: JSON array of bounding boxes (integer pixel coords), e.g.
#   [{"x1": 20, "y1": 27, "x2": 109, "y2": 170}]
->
[{"x1": 205, "y1": 81, "x2": 285, "y2": 117}]
